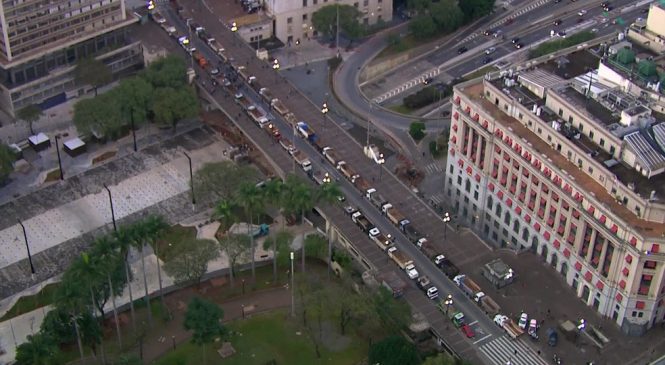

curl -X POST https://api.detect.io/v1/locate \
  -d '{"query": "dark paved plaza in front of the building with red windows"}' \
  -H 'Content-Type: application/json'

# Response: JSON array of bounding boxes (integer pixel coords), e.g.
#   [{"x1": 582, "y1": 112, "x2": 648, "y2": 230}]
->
[{"x1": 459, "y1": 250, "x2": 665, "y2": 365}]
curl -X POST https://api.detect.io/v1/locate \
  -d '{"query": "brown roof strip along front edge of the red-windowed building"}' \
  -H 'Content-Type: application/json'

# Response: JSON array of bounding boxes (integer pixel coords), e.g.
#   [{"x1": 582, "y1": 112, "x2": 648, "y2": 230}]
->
[{"x1": 457, "y1": 80, "x2": 665, "y2": 237}]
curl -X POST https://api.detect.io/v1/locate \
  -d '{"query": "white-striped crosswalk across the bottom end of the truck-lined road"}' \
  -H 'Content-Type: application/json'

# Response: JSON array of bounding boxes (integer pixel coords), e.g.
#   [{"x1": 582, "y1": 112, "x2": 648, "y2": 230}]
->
[{"x1": 480, "y1": 335, "x2": 548, "y2": 365}]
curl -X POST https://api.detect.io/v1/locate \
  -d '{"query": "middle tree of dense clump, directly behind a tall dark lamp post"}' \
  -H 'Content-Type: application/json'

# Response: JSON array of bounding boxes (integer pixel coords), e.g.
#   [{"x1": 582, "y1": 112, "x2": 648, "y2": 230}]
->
[{"x1": 114, "y1": 77, "x2": 153, "y2": 132}]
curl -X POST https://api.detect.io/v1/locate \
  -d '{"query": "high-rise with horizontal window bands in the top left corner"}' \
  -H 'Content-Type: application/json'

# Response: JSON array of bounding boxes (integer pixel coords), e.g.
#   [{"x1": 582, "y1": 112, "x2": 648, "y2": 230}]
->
[{"x1": 0, "y1": 0, "x2": 142, "y2": 116}]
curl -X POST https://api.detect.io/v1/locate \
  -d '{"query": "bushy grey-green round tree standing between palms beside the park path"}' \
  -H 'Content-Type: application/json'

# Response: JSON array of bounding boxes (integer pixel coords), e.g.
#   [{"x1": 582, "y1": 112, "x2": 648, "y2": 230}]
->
[{"x1": 164, "y1": 238, "x2": 219, "y2": 284}]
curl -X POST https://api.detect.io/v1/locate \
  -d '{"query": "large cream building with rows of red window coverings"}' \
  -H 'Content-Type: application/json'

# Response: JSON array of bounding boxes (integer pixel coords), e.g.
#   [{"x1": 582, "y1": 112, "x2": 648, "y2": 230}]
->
[{"x1": 445, "y1": 70, "x2": 665, "y2": 334}]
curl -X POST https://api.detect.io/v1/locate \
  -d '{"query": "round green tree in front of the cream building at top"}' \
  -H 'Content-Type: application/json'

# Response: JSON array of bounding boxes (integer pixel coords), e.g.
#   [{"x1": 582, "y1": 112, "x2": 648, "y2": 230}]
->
[{"x1": 312, "y1": 5, "x2": 361, "y2": 39}]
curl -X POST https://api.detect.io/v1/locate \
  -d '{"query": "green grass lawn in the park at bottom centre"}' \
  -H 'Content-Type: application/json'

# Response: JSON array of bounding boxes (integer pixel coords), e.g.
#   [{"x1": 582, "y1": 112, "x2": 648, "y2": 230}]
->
[{"x1": 154, "y1": 310, "x2": 368, "y2": 365}]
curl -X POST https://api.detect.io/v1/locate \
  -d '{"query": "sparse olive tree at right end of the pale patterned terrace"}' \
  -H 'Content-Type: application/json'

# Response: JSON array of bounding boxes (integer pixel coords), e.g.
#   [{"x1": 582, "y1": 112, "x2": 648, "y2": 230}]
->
[{"x1": 194, "y1": 161, "x2": 257, "y2": 201}]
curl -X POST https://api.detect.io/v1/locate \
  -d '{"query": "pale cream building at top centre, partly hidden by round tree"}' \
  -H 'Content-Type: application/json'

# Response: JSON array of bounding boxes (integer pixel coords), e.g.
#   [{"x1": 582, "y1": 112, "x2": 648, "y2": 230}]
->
[{"x1": 264, "y1": 0, "x2": 393, "y2": 45}]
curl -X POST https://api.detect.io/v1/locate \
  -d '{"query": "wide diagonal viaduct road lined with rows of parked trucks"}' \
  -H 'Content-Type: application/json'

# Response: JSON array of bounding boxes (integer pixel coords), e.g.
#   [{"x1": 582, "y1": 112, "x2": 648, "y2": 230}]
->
[{"x1": 164, "y1": 1, "x2": 546, "y2": 365}]
